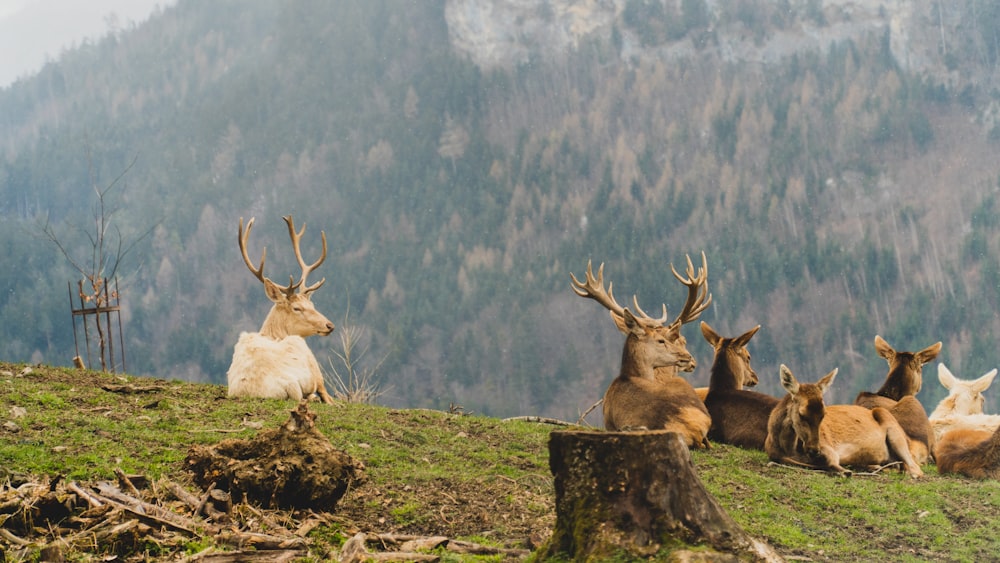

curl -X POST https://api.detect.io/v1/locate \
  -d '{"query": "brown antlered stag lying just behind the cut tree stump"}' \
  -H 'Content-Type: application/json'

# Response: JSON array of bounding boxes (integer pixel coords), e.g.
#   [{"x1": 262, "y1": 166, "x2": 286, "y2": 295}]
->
[{"x1": 570, "y1": 254, "x2": 711, "y2": 448}]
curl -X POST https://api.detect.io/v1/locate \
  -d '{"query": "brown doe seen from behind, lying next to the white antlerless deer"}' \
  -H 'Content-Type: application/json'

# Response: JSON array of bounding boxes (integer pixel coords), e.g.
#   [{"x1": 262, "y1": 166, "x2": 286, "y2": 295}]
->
[{"x1": 854, "y1": 335, "x2": 941, "y2": 465}]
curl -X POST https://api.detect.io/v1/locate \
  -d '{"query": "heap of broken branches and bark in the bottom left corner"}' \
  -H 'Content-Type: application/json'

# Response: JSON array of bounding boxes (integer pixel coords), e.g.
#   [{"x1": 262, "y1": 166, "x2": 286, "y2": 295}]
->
[{"x1": 0, "y1": 472, "x2": 312, "y2": 561}]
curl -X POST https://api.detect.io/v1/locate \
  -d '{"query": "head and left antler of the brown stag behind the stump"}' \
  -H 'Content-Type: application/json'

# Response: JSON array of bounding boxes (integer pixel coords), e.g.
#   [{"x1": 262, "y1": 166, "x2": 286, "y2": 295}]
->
[{"x1": 570, "y1": 262, "x2": 695, "y2": 379}]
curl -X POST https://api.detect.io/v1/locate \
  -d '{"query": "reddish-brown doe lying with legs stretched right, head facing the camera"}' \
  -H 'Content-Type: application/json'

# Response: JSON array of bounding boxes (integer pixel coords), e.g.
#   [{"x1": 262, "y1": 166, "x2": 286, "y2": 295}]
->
[{"x1": 764, "y1": 364, "x2": 924, "y2": 478}]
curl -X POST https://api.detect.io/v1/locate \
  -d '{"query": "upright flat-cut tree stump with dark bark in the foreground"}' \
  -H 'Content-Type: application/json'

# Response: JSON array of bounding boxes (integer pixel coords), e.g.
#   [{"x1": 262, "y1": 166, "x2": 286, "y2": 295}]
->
[{"x1": 541, "y1": 431, "x2": 782, "y2": 561}]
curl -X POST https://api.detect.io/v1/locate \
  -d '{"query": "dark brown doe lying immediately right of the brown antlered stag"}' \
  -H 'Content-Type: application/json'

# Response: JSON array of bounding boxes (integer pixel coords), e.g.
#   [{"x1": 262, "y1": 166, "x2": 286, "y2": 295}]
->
[{"x1": 701, "y1": 321, "x2": 778, "y2": 450}]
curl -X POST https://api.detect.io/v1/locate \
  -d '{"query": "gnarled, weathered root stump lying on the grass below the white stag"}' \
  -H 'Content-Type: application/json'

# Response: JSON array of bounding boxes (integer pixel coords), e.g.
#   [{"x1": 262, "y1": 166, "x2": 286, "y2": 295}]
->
[{"x1": 184, "y1": 401, "x2": 364, "y2": 511}]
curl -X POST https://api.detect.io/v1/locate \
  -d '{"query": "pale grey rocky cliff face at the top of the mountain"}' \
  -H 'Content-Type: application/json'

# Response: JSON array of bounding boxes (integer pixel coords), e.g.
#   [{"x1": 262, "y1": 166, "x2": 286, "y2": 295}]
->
[{"x1": 445, "y1": 0, "x2": 963, "y2": 82}]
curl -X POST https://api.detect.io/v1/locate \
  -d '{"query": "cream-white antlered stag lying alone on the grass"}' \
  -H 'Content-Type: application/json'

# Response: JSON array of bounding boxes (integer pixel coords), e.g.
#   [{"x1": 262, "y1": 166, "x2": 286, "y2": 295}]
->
[{"x1": 227, "y1": 215, "x2": 333, "y2": 403}]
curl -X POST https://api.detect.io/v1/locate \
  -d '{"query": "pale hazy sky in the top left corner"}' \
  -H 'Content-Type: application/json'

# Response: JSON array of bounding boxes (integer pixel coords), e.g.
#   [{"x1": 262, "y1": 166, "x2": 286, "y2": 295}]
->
[{"x1": 0, "y1": 0, "x2": 174, "y2": 88}]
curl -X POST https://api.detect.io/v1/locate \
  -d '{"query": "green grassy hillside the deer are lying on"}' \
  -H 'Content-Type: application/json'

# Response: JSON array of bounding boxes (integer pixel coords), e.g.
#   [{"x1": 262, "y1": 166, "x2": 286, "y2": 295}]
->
[{"x1": 0, "y1": 363, "x2": 1000, "y2": 561}]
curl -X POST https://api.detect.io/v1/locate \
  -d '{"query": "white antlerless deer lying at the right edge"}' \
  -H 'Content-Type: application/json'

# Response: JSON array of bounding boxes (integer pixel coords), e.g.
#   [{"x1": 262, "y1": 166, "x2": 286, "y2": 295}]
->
[{"x1": 930, "y1": 364, "x2": 1000, "y2": 446}]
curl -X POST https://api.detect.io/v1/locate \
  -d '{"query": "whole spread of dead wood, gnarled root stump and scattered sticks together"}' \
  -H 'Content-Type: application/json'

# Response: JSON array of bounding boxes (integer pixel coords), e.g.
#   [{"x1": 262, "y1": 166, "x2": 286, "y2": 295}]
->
[{"x1": 0, "y1": 403, "x2": 529, "y2": 563}]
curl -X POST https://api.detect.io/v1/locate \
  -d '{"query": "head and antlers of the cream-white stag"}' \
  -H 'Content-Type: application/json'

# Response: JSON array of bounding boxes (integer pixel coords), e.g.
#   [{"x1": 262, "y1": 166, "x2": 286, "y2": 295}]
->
[{"x1": 239, "y1": 215, "x2": 333, "y2": 340}]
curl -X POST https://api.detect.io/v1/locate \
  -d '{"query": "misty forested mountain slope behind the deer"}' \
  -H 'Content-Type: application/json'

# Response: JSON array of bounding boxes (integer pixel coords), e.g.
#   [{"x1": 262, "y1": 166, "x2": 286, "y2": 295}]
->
[{"x1": 0, "y1": 0, "x2": 1000, "y2": 419}]
